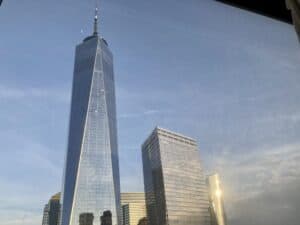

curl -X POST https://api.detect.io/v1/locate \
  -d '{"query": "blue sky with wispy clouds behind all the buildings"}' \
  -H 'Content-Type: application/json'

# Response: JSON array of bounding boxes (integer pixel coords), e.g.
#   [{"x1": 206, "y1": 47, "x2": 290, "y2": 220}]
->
[{"x1": 0, "y1": 0, "x2": 300, "y2": 225}]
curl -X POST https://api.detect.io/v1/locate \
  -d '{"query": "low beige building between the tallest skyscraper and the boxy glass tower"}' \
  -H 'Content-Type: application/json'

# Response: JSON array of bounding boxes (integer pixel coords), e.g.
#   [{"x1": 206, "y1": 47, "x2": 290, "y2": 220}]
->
[{"x1": 121, "y1": 192, "x2": 146, "y2": 225}]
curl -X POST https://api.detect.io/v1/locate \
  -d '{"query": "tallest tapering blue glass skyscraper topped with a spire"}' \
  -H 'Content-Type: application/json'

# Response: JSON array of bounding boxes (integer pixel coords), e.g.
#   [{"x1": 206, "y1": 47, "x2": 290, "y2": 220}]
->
[{"x1": 61, "y1": 11, "x2": 121, "y2": 225}]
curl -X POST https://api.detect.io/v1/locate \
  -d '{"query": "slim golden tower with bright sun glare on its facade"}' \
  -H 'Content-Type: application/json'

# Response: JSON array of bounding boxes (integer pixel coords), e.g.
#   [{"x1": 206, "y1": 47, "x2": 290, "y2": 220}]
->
[{"x1": 207, "y1": 173, "x2": 227, "y2": 225}]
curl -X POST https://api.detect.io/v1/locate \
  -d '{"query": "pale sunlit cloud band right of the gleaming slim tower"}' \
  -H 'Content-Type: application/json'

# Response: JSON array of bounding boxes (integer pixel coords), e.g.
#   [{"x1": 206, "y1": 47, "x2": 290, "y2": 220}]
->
[{"x1": 212, "y1": 143, "x2": 300, "y2": 211}]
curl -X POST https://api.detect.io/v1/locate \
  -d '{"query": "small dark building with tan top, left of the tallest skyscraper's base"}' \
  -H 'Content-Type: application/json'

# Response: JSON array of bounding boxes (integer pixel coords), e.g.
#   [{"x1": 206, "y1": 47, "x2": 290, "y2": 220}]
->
[{"x1": 42, "y1": 193, "x2": 60, "y2": 225}]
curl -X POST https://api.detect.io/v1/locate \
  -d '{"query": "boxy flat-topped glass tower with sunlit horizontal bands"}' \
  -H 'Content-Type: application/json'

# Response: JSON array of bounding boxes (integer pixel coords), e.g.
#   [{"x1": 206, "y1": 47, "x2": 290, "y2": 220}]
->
[{"x1": 142, "y1": 128, "x2": 210, "y2": 225}]
